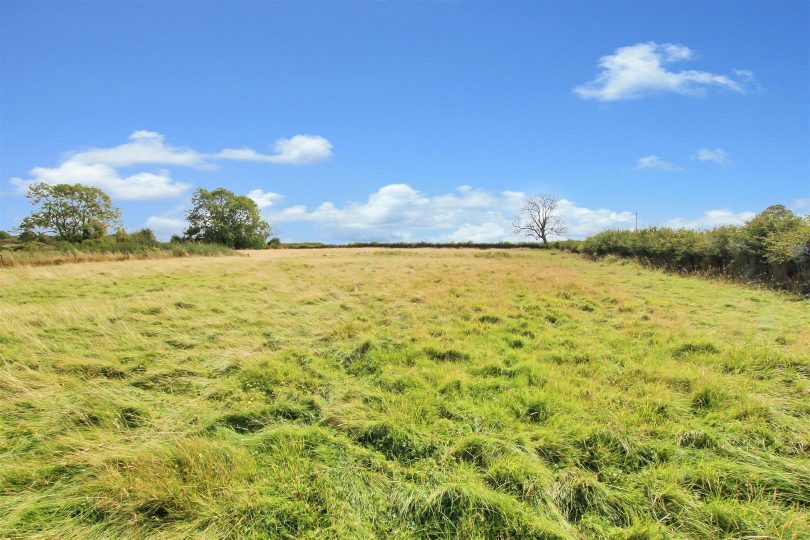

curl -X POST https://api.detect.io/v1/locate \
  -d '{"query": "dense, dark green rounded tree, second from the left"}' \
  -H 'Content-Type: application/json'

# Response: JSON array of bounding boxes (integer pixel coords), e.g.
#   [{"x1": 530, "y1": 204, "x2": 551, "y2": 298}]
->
[{"x1": 185, "y1": 188, "x2": 270, "y2": 249}]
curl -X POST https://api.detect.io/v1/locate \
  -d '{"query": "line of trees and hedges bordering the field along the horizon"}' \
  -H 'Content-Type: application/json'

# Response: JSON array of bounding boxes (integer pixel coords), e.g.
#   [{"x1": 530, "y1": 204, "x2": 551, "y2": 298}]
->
[{"x1": 0, "y1": 183, "x2": 810, "y2": 293}]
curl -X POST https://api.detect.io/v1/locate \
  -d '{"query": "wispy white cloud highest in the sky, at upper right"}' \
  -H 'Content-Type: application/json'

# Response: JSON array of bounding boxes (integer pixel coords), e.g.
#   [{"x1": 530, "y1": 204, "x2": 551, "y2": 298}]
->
[{"x1": 574, "y1": 41, "x2": 754, "y2": 101}]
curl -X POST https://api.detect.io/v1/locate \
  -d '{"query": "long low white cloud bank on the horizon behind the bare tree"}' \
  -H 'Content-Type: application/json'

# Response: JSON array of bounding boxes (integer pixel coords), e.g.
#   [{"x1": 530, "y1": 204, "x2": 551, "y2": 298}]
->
[{"x1": 268, "y1": 184, "x2": 634, "y2": 242}]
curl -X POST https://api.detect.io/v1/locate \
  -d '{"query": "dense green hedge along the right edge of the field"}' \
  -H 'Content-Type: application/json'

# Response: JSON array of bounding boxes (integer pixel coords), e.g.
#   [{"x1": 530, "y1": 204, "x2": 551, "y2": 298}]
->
[{"x1": 583, "y1": 205, "x2": 810, "y2": 293}]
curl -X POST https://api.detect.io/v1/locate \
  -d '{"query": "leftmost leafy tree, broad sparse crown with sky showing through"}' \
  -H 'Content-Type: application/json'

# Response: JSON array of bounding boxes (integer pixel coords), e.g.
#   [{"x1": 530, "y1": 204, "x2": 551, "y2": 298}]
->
[{"x1": 19, "y1": 183, "x2": 121, "y2": 243}]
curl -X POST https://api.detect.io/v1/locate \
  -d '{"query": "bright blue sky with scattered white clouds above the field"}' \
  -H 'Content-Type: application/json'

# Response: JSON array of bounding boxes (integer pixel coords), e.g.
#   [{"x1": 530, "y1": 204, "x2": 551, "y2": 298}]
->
[{"x1": 0, "y1": 0, "x2": 810, "y2": 241}]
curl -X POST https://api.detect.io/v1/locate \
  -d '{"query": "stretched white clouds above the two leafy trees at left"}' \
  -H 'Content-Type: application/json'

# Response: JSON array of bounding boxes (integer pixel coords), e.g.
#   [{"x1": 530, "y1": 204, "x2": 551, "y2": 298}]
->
[{"x1": 9, "y1": 130, "x2": 332, "y2": 200}]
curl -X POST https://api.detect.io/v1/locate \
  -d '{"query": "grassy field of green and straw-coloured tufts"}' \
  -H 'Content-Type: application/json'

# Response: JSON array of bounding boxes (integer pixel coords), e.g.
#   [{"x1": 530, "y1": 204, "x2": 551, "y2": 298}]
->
[{"x1": 0, "y1": 249, "x2": 810, "y2": 539}]
